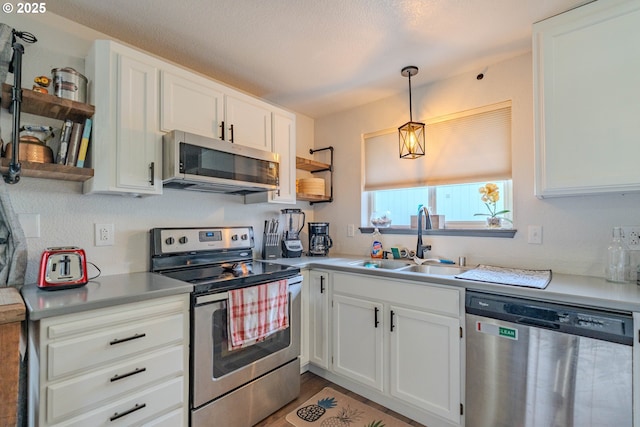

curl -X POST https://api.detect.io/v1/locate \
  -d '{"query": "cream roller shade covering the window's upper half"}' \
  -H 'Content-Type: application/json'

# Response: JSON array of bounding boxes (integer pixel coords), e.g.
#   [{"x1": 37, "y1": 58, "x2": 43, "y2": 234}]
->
[{"x1": 363, "y1": 102, "x2": 511, "y2": 191}]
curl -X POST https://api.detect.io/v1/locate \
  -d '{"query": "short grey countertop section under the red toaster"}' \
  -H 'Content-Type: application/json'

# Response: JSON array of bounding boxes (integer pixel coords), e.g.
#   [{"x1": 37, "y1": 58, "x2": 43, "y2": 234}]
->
[{"x1": 20, "y1": 272, "x2": 193, "y2": 320}]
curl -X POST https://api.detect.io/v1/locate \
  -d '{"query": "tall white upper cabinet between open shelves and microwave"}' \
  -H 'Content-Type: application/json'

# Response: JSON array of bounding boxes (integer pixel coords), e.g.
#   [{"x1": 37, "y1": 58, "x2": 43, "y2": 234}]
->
[{"x1": 83, "y1": 40, "x2": 162, "y2": 195}]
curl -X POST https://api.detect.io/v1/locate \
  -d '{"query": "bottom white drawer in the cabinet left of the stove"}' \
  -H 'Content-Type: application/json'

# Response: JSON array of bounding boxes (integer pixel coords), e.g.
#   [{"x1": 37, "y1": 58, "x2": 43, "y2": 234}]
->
[{"x1": 55, "y1": 377, "x2": 186, "y2": 427}]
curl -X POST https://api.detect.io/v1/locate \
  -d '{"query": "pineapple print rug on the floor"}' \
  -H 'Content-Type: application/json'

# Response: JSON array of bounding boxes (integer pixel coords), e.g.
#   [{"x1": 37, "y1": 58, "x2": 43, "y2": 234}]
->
[{"x1": 286, "y1": 387, "x2": 410, "y2": 427}]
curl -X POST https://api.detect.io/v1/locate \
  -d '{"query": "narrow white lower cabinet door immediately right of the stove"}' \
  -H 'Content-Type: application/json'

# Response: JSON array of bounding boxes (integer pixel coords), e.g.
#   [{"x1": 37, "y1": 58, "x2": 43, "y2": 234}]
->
[{"x1": 309, "y1": 270, "x2": 330, "y2": 369}]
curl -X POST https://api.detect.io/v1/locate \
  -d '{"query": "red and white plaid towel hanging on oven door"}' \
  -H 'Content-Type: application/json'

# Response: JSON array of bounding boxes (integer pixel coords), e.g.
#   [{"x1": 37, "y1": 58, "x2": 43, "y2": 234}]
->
[{"x1": 228, "y1": 280, "x2": 289, "y2": 350}]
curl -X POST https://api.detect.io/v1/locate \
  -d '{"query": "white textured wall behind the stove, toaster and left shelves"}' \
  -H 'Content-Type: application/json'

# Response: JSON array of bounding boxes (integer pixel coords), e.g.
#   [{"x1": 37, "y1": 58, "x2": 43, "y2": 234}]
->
[{"x1": 0, "y1": 12, "x2": 314, "y2": 283}]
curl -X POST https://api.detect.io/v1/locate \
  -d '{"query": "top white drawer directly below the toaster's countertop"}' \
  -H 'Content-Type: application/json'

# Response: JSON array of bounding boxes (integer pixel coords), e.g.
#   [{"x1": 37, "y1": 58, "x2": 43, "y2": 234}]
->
[{"x1": 47, "y1": 313, "x2": 185, "y2": 381}]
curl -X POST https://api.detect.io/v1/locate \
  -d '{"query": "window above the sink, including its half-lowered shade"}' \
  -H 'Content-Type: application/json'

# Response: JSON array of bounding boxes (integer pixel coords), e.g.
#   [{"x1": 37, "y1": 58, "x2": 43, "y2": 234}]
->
[{"x1": 363, "y1": 102, "x2": 513, "y2": 228}]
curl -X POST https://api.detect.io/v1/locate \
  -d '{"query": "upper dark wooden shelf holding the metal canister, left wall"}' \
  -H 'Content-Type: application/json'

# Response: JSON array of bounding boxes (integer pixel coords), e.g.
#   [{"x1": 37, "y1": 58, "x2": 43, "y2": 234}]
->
[{"x1": 2, "y1": 83, "x2": 95, "y2": 122}]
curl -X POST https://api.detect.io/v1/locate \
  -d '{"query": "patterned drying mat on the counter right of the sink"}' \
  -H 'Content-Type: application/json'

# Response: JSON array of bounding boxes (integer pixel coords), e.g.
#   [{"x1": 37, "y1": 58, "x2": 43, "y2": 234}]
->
[{"x1": 456, "y1": 264, "x2": 551, "y2": 289}]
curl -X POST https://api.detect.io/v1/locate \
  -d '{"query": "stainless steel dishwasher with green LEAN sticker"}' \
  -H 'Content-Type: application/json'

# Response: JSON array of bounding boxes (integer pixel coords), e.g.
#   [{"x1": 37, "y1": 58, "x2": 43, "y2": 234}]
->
[{"x1": 465, "y1": 291, "x2": 633, "y2": 427}]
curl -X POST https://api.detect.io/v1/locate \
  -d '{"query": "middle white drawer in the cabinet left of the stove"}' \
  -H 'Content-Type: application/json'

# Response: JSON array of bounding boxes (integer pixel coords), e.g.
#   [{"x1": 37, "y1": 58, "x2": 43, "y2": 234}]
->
[{"x1": 46, "y1": 346, "x2": 185, "y2": 423}]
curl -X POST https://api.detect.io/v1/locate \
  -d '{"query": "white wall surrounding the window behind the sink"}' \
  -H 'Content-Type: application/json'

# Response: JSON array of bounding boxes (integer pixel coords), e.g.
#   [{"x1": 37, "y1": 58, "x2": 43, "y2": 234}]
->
[{"x1": 315, "y1": 54, "x2": 640, "y2": 276}]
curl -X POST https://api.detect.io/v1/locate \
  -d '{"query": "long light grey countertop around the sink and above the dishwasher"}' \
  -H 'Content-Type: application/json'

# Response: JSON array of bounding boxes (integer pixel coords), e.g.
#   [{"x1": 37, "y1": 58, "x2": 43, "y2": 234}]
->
[{"x1": 270, "y1": 255, "x2": 640, "y2": 312}]
